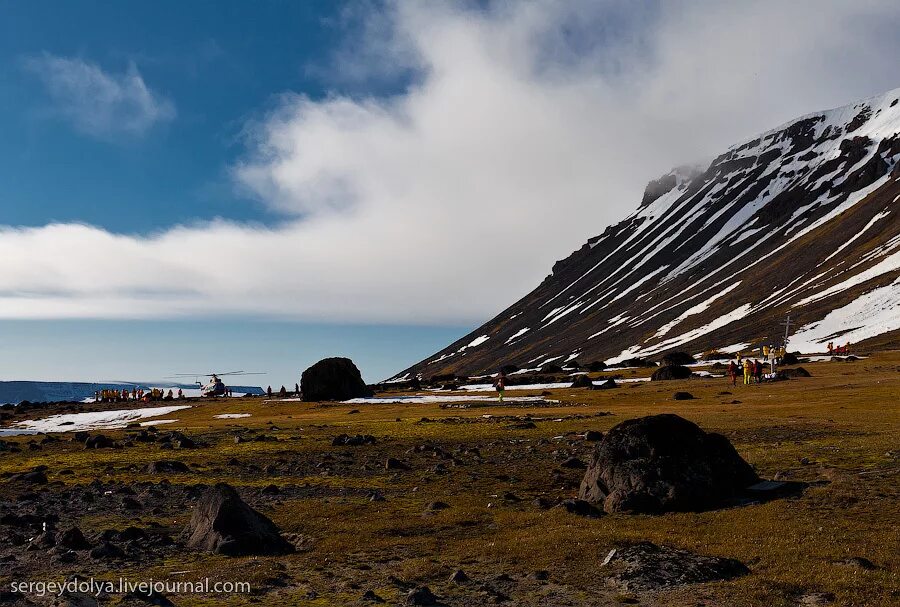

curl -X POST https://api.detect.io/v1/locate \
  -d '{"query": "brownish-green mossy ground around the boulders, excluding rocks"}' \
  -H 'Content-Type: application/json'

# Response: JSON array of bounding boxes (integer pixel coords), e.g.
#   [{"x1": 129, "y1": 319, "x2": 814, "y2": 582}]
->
[{"x1": 0, "y1": 352, "x2": 900, "y2": 606}]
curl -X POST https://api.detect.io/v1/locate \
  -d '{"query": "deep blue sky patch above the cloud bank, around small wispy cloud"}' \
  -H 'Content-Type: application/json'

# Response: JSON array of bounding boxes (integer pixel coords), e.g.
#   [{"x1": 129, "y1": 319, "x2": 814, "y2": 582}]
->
[{"x1": 0, "y1": 1, "x2": 343, "y2": 232}]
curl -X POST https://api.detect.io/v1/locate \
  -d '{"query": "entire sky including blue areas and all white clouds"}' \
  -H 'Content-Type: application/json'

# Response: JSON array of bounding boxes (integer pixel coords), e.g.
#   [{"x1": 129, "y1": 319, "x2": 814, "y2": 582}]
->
[{"x1": 0, "y1": 0, "x2": 900, "y2": 384}]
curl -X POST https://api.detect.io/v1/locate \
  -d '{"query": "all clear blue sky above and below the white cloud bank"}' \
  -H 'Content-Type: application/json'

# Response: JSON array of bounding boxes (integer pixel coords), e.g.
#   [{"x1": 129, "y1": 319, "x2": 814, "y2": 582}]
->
[{"x1": 0, "y1": 0, "x2": 469, "y2": 388}]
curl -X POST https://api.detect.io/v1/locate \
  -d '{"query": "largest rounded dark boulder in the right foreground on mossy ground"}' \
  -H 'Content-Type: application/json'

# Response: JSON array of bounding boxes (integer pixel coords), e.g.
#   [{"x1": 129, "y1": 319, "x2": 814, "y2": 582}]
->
[{"x1": 578, "y1": 414, "x2": 759, "y2": 513}]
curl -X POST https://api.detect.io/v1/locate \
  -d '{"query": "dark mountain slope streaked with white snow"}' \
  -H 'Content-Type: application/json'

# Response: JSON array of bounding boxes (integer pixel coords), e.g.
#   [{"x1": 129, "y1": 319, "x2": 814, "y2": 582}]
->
[{"x1": 397, "y1": 89, "x2": 900, "y2": 378}]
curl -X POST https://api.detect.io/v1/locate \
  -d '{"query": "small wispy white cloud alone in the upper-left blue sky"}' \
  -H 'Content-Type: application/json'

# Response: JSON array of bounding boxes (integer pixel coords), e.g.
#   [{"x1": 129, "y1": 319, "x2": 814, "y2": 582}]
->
[{"x1": 25, "y1": 53, "x2": 175, "y2": 139}]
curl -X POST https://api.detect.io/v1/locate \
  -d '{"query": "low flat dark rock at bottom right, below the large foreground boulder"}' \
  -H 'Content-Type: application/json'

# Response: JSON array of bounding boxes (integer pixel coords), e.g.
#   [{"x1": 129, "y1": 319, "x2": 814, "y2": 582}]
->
[{"x1": 602, "y1": 542, "x2": 750, "y2": 590}]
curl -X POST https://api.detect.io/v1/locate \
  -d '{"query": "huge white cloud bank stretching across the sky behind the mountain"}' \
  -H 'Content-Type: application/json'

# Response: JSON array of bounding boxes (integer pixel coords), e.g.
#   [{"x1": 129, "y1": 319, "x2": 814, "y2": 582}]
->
[{"x1": 0, "y1": 0, "x2": 900, "y2": 323}]
